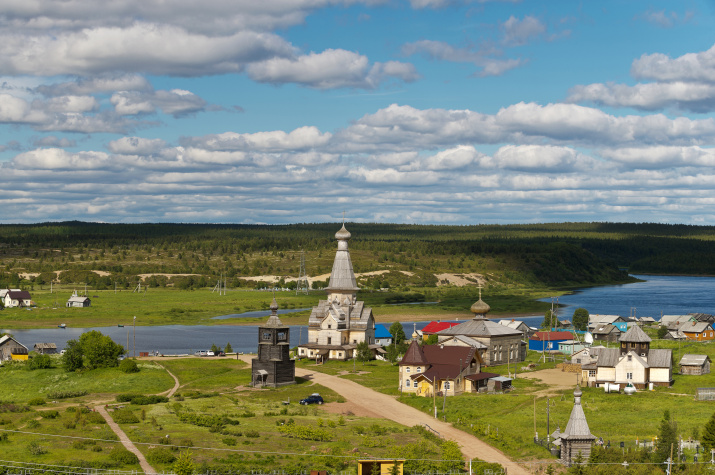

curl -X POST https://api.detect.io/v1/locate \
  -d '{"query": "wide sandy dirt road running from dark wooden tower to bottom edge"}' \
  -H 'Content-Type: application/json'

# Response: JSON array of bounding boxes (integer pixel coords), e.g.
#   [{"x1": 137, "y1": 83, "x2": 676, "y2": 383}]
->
[{"x1": 242, "y1": 355, "x2": 531, "y2": 475}]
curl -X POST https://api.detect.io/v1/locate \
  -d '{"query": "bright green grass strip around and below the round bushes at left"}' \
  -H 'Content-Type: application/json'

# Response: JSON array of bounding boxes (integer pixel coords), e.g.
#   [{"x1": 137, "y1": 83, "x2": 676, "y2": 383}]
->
[{"x1": 0, "y1": 360, "x2": 174, "y2": 403}]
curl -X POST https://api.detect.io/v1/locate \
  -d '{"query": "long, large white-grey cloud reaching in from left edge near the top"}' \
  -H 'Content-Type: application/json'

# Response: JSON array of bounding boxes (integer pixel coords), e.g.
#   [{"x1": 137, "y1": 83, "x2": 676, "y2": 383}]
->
[{"x1": 0, "y1": 22, "x2": 294, "y2": 76}]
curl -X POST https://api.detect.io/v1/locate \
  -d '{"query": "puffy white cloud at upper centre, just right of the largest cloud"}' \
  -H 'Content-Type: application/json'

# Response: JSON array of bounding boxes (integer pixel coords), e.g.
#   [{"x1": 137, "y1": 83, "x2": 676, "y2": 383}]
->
[{"x1": 247, "y1": 49, "x2": 418, "y2": 89}]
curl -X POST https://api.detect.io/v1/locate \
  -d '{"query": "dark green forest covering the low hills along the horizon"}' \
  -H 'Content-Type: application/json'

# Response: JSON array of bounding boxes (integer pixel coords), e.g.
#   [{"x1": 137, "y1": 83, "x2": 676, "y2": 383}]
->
[{"x1": 0, "y1": 222, "x2": 715, "y2": 290}]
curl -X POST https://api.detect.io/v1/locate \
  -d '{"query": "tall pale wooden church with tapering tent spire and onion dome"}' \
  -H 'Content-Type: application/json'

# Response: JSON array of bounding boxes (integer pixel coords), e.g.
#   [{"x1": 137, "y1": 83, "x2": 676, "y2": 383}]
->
[{"x1": 298, "y1": 224, "x2": 382, "y2": 360}]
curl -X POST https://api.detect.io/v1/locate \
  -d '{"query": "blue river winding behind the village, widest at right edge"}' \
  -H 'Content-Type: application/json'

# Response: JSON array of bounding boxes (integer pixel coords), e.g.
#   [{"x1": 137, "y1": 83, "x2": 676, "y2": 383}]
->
[{"x1": 2, "y1": 275, "x2": 715, "y2": 355}]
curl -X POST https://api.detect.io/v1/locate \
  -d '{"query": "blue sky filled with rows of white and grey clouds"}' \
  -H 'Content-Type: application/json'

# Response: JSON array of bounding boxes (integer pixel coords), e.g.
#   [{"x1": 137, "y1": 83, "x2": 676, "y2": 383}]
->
[{"x1": 0, "y1": 0, "x2": 715, "y2": 225}]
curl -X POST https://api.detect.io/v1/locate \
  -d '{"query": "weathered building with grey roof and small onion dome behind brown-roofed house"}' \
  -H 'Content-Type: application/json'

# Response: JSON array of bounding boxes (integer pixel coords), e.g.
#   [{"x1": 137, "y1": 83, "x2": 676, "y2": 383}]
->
[{"x1": 430, "y1": 290, "x2": 526, "y2": 366}]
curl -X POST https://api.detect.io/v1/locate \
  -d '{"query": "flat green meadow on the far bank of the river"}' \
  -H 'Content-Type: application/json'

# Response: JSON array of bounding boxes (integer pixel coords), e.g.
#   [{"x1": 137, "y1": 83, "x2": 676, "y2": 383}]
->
[{"x1": 2, "y1": 288, "x2": 548, "y2": 329}]
